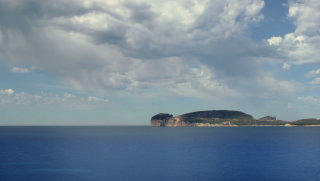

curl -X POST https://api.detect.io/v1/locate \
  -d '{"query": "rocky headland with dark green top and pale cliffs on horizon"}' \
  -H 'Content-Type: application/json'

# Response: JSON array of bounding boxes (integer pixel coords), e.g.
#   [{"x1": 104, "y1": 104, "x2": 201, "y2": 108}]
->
[{"x1": 151, "y1": 110, "x2": 320, "y2": 127}]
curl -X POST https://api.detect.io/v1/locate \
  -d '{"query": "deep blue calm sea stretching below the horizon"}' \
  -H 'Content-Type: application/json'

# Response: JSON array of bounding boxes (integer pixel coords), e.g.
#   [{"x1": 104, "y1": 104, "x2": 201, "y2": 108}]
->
[{"x1": 0, "y1": 126, "x2": 320, "y2": 181}]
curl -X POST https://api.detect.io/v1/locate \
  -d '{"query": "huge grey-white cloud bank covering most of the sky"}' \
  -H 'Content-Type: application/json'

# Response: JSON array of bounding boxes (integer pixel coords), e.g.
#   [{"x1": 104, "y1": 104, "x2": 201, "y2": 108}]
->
[{"x1": 0, "y1": 0, "x2": 300, "y2": 107}]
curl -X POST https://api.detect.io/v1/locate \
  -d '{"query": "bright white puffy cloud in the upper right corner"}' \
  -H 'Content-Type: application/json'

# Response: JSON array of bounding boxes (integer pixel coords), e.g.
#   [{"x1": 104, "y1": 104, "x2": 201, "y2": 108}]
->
[{"x1": 268, "y1": 0, "x2": 320, "y2": 64}]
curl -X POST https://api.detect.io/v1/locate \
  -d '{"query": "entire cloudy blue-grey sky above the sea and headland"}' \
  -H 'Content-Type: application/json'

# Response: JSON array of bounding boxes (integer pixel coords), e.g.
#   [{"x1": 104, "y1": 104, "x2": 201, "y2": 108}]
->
[{"x1": 0, "y1": 0, "x2": 320, "y2": 125}]
